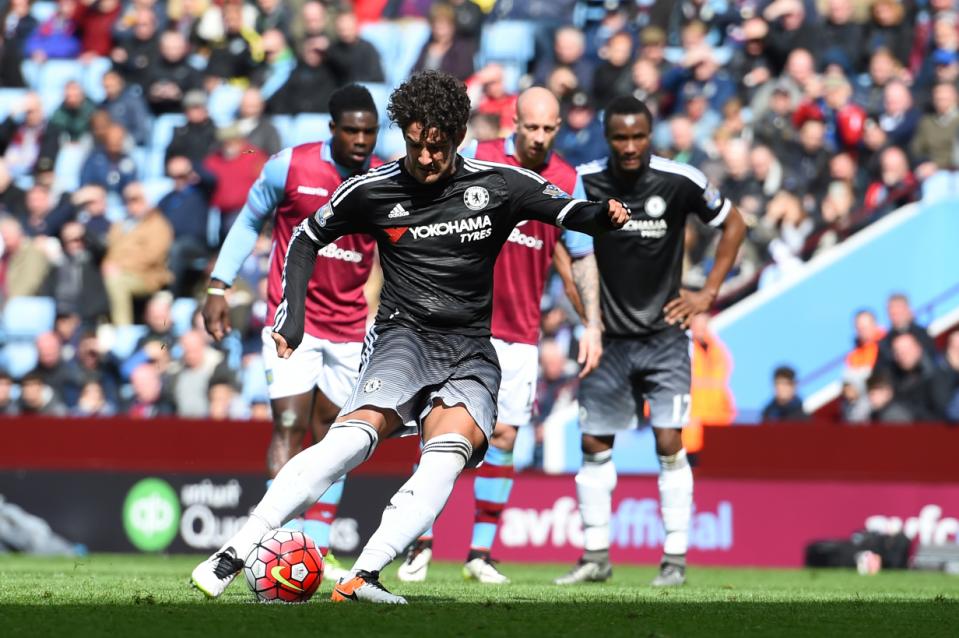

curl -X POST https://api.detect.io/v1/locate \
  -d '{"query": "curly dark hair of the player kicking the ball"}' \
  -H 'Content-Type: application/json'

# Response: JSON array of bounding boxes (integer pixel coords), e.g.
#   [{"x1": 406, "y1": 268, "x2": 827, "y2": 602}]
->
[{"x1": 386, "y1": 71, "x2": 470, "y2": 138}]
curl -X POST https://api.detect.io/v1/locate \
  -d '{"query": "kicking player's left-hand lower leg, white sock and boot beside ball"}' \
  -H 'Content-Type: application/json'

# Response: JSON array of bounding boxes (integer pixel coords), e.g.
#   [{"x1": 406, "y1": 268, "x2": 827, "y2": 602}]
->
[{"x1": 192, "y1": 415, "x2": 378, "y2": 598}]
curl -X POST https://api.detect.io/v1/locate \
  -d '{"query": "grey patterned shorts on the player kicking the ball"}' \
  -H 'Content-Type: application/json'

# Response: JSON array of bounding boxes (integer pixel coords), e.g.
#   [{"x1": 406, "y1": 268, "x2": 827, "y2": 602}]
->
[{"x1": 340, "y1": 324, "x2": 500, "y2": 467}]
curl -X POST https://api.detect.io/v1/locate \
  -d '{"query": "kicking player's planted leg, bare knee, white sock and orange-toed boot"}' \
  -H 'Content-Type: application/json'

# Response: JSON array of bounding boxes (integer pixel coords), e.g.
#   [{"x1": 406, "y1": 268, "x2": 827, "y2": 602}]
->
[{"x1": 331, "y1": 405, "x2": 485, "y2": 604}]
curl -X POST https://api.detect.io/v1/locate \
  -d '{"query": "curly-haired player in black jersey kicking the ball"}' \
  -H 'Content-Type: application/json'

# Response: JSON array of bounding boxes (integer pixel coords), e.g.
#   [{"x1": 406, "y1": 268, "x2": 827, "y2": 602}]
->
[{"x1": 193, "y1": 71, "x2": 629, "y2": 604}]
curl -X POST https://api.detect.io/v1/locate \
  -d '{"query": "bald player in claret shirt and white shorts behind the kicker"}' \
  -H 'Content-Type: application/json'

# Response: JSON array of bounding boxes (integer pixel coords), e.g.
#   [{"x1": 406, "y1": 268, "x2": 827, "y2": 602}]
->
[{"x1": 397, "y1": 87, "x2": 602, "y2": 584}]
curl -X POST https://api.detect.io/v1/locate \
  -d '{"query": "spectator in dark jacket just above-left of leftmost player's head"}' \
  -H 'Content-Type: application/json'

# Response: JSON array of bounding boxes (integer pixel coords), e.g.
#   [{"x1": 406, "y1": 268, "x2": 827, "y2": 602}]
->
[{"x1": 268, "y1": 36, "x2": 339, "y2": 115}]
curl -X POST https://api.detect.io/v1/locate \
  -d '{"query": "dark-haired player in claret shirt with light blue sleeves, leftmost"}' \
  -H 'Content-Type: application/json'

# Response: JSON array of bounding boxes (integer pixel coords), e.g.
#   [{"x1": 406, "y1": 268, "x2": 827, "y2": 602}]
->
[{"x1": 197, "y1": 84, "x2": 382, "y2": 574}]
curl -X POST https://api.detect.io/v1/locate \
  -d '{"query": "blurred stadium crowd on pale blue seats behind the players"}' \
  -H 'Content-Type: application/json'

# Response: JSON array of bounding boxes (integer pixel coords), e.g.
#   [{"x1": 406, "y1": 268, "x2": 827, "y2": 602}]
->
[{"x1": 0, "y1": 0, "x2": 959, "y2": 422}]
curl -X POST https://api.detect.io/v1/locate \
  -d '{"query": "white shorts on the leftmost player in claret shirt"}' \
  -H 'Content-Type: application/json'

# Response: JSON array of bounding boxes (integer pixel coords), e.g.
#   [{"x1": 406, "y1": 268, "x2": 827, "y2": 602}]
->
[{"x1": 262, "y1": 326, "x2": 363, "y2": 406}]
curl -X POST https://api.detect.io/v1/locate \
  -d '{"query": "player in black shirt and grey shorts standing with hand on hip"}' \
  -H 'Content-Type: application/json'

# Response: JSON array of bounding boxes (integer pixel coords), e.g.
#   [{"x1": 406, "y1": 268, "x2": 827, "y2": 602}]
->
[{"x1": 556, "y1": 97, "x2": 745, "y2": 586}]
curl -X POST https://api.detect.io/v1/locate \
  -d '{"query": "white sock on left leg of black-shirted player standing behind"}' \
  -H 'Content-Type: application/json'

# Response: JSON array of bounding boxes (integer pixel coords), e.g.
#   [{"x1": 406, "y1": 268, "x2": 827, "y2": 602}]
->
[{"x1": 576, "y1": 450, "x2": 616, "y2": 552}]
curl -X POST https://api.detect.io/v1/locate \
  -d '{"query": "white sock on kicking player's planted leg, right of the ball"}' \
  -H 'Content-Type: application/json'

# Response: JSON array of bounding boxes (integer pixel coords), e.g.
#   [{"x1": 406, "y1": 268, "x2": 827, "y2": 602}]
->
[{"x1": 353, "y1": 434, "x2": 473, "y2": 573}]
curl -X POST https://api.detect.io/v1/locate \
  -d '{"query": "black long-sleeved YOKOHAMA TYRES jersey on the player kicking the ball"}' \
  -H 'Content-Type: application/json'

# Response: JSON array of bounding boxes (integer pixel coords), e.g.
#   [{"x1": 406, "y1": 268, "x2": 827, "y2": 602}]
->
[{"x1": 274, "y1": 156, "x2": 624, "y2": 347}]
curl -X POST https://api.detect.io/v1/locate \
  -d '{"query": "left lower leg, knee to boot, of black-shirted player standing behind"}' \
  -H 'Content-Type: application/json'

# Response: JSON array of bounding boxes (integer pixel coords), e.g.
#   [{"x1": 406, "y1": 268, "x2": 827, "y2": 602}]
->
[{"x1": 553, "y1": 434, "x2": 616, "y2": 585}]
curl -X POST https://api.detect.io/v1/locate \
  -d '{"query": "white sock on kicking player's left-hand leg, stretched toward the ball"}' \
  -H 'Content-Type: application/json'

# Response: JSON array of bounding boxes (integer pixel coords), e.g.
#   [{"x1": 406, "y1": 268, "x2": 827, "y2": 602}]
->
[{"x1": 223, "y1": 419, "x2": 377, "y2": 558}]
